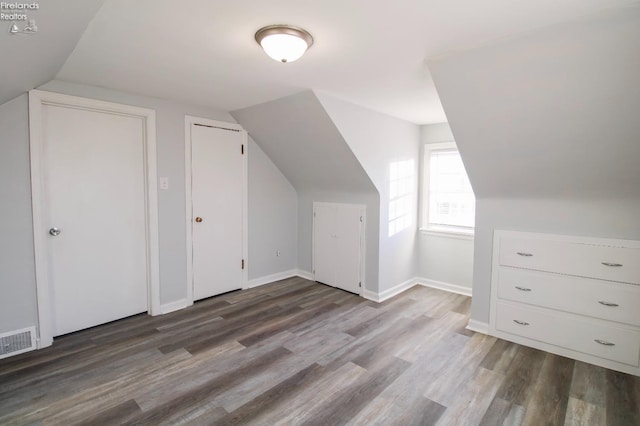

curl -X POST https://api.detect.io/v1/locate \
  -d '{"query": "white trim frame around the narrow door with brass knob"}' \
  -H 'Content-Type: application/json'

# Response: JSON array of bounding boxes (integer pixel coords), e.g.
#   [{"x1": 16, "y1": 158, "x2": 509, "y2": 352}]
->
[{"x1": 184, "y1": 115, "x2": 249, "y2": 306}]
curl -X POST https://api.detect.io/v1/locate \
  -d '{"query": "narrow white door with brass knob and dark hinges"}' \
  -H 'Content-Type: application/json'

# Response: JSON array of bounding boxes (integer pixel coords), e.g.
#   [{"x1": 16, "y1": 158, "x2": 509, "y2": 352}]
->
[{"x1": 191, "y1": 124, "x2": 244, "y2": 300}]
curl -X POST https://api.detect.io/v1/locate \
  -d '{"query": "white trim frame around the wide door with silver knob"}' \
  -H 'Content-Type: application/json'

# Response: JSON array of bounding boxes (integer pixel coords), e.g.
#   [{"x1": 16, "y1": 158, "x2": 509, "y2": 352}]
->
[{"x1": 29, "y1": 90, "x2": 160, "y2": 349}]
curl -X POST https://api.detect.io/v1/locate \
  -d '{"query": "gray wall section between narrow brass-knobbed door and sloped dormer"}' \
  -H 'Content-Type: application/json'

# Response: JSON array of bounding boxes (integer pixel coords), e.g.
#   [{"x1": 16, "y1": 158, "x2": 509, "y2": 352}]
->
[{"x1": 249, "y1": 138, "x2": 298, "y2": 280}]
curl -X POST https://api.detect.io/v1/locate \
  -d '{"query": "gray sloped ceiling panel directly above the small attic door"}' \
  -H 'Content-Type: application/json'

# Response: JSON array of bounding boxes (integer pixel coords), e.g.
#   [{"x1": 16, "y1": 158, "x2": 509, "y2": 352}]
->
[{"x1": 231, "y1": 91, "x2": 375, "y2": 192}]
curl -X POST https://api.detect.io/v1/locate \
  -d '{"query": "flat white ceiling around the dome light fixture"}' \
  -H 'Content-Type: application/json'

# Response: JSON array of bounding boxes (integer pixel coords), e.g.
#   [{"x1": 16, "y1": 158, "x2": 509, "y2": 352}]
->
[{"x1": 57, "y1": 0, "x2": 637, "y2": 124}]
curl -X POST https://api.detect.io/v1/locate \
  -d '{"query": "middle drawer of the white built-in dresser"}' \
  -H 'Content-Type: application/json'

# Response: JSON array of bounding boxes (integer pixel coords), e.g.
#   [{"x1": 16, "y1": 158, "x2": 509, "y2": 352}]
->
[{"x1": 498, "y1": 266, "x2": 640, "y2": 326}]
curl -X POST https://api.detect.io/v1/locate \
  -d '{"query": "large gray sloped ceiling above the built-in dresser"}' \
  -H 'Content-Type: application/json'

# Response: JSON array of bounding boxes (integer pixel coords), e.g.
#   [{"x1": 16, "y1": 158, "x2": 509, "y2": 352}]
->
[{"x1": 430, "y1": 4, "x2": 640, "y2": 199}]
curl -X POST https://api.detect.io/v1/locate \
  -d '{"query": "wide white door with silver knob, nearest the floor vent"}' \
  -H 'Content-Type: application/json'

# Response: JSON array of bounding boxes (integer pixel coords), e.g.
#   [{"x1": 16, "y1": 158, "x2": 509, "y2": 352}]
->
[{"x1": 42, "y1": 105, "x2": 148, "y2": 336}]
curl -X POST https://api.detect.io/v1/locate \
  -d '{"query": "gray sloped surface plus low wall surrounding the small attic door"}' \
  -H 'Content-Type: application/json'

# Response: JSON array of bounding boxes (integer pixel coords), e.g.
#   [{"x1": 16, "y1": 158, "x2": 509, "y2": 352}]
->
[{"x1": 232, "y1": 91, "x2": 379, "y2": 291}]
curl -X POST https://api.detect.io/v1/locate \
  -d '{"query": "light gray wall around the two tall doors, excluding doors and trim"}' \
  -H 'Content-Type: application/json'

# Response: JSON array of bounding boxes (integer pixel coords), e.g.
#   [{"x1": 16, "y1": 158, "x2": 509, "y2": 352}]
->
[{"x1": 0, "y1": 80, "x2": 297, "y2": 332}]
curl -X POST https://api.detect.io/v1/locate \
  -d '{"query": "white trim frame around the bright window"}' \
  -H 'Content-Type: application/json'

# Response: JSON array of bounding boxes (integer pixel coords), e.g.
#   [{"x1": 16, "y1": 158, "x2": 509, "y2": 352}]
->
[{"x1": 420, "y1": 142, "x2": 475, "y2": 239}]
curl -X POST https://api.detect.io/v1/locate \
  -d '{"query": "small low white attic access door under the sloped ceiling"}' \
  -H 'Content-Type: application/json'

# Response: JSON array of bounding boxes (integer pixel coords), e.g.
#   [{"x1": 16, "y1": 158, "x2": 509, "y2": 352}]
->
[{"x1": 313, "y1": 202, "x2": 366, "y2": 294}]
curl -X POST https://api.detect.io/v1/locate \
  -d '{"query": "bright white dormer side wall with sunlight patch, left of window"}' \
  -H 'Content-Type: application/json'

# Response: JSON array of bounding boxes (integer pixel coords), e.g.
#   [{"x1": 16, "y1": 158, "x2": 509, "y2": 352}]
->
[{"x1": 316, "y1": 93, "x2": 420, "y2": 293}]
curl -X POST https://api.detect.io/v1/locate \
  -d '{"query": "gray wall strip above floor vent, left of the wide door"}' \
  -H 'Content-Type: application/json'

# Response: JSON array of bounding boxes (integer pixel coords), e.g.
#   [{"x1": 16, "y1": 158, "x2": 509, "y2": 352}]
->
[{"x1": 0, "y1": 94, "x2": 37, "y2": 333}]
